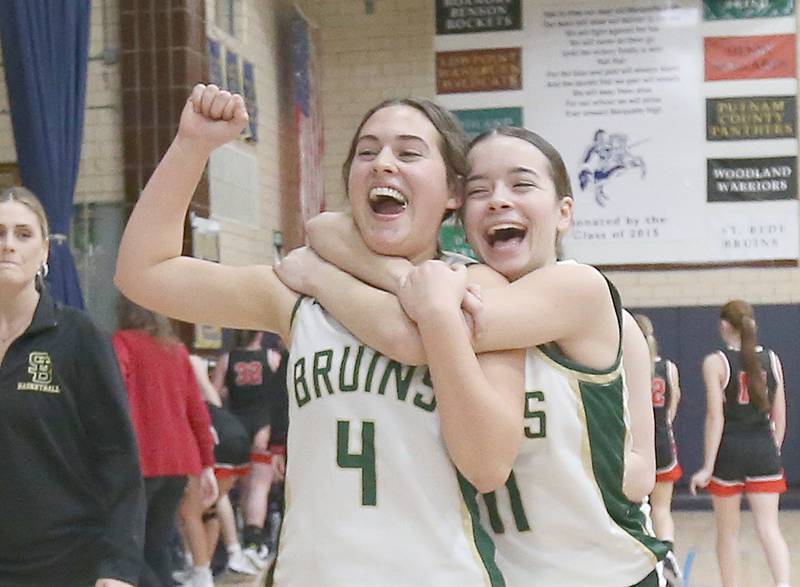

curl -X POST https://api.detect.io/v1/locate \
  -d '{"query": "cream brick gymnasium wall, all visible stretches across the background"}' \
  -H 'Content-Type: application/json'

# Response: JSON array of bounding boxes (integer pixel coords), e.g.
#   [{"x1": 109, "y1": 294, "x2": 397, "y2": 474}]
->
[{"x1": 0, "y1": 0, "x2": 800, "y2": 307}]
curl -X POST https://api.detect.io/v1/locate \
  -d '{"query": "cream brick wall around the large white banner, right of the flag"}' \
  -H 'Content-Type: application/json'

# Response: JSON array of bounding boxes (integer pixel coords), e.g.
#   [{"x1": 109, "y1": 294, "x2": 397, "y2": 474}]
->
[{"x1": 304, "y1": 0, "x2": 800, "y2": 307}]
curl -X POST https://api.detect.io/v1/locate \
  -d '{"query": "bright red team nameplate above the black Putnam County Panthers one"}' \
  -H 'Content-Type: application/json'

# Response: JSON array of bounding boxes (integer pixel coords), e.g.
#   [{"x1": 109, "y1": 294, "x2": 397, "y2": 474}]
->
[{"x1": 705, "y1": 35, "x2": 797, "y2": 81}]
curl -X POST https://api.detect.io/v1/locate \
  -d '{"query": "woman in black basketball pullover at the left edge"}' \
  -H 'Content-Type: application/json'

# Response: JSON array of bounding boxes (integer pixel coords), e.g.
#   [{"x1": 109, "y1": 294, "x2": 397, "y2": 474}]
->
[{"x1": 0, "y1": 187, "x2": 144, "y2": 587}]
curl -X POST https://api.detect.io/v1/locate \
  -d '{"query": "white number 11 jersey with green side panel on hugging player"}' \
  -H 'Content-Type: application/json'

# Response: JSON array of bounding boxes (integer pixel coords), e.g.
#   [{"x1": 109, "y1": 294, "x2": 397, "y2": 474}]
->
[{"x1": 481, "y1": 272, "x2": 666, "y2": 587}]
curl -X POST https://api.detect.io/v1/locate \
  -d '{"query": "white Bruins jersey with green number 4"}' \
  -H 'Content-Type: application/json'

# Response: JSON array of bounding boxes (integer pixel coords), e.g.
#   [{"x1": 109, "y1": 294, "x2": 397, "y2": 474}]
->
[{"x1": 275, "y1": 298, "x2": 505, "y2": 587}]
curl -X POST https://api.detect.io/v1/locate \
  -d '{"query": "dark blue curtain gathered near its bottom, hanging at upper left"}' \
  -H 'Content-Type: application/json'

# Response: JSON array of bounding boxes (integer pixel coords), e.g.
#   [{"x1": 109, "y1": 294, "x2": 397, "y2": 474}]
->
[{"x1": 0, "y1": 0, "x2": 90, "y2": 307}]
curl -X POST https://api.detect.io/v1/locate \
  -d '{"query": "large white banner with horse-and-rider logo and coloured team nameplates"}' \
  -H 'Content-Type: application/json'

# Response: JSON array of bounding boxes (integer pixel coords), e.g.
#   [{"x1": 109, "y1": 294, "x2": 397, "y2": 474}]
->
[{"x1": 435, "y1": 0, "x2": 800, "y2": 265}]
